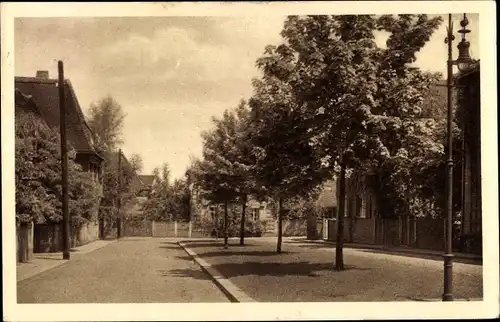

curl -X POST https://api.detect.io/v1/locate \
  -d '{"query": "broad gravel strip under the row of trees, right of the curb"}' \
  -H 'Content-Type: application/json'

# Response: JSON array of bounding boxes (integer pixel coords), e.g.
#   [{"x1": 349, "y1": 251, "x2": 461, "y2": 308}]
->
[{"x1": 183, "y1": 239, "x2": 482, "y2": 302}]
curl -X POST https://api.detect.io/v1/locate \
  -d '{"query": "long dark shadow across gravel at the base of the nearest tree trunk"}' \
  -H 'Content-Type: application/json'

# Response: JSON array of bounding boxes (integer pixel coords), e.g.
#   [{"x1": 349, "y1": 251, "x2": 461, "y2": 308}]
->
[{"x1": 212, "y1": 261, "x2": 371, "y2": 278}]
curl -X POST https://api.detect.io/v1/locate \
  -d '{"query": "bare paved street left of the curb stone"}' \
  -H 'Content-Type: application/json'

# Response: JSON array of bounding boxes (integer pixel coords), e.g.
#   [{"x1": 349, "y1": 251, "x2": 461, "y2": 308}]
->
[{"x1": 17, "y1": 238, "x2": 229, "y2": 303}]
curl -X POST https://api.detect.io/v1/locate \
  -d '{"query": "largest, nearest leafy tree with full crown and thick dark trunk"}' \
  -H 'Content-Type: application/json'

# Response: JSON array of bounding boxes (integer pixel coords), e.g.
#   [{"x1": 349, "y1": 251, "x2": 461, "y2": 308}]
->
[{"x1": 260, "y1": 15, "x2": 442, "y2": 269}]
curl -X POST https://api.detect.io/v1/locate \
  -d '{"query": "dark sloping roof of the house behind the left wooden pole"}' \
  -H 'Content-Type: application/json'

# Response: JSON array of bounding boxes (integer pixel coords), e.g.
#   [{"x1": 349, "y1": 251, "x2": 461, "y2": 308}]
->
[{"x1": 15, "y1": 77, "x2": 102, "y2": 158}]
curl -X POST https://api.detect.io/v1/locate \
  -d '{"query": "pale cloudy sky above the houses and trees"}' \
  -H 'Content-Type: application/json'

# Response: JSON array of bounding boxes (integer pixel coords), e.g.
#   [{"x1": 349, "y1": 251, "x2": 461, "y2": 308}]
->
[{"x1": 14, "y1": 15, "x2": 479, "y2": 178}]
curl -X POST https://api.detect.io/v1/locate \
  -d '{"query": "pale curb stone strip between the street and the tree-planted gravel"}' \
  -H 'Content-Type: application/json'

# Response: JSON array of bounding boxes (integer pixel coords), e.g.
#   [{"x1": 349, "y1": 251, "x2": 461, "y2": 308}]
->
[{"x1": 178, "y1": 242, "x2": 257, "y2": 303}]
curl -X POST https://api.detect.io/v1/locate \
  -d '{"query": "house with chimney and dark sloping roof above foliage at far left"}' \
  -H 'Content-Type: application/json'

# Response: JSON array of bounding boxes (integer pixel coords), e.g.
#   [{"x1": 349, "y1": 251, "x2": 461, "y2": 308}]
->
[{"x1": 15, "y1": 71, "x2": 104, "y2": 181}]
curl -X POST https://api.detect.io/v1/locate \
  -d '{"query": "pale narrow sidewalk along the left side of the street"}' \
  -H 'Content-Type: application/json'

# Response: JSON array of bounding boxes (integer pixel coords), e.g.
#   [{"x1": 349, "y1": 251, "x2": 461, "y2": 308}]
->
[{"x1": 16, "y1": 240, "x2": 116, "y2": 282}]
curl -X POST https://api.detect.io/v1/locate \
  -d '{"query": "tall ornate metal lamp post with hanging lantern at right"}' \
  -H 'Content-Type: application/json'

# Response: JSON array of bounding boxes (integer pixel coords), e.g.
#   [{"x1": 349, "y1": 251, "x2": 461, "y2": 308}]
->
[{"x1": 443, "y1": 13, "x2": 473, "y2": 301}]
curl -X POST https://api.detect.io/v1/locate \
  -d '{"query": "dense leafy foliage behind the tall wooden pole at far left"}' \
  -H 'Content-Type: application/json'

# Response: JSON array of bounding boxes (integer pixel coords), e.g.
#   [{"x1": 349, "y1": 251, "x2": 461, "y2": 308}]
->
[{"x1": 15, "y1": 113, "x2": 100, "y2": 228}]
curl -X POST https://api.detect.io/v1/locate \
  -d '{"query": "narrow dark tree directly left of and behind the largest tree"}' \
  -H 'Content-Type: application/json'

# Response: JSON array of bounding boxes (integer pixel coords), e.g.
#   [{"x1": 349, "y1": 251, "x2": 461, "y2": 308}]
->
[{"x1": 249, "y1": 46, "x2": 328, "y2": 253}]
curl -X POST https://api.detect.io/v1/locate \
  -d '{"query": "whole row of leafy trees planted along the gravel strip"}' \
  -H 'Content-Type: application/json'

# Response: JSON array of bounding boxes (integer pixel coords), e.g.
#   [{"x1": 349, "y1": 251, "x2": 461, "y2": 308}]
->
[{"x1": 190, "y1": 15, "x2": 454, "y2": 269}]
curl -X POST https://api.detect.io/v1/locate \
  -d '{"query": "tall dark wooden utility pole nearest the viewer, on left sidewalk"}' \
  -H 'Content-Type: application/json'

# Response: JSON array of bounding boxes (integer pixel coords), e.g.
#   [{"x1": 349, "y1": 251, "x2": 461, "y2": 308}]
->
[{"x1": 57, "y1": 61, "x2": 71, "y2": 259}]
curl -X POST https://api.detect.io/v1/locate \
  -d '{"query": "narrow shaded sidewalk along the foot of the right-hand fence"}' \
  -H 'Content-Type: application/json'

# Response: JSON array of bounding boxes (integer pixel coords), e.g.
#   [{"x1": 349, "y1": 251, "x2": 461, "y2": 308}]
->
[{"x1": 290, "y1": 237, "x2": 483, "y2": 264}]
